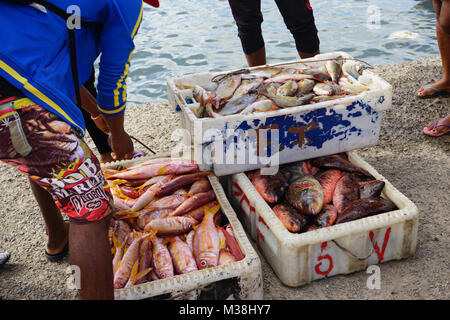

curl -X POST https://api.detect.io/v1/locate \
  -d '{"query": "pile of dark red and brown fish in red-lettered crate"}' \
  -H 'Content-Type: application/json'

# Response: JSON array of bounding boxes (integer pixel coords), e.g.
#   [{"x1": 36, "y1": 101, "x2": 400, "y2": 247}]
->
[{"x1": 247, "y1": 154, "x2": 396, "y2": 233}]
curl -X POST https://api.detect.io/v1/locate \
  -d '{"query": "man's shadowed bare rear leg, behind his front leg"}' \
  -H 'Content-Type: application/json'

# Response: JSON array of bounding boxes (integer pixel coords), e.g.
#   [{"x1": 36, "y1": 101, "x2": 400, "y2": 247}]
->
[{"x1": 29, "y1": 178, "x2": 69, "y2": 254}]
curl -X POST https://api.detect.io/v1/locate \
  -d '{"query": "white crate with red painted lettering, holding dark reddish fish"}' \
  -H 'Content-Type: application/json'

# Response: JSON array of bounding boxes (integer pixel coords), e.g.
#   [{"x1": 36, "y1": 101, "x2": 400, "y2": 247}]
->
[{"x1": 229, "y1": 151, "x2": 418, "y2": 287}]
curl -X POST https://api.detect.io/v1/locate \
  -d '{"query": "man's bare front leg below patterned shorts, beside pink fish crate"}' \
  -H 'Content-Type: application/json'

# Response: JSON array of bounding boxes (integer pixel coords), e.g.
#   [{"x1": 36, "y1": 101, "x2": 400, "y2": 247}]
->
[{"x1": 69, "y1": 218, "x2": 114, "y2": 300}]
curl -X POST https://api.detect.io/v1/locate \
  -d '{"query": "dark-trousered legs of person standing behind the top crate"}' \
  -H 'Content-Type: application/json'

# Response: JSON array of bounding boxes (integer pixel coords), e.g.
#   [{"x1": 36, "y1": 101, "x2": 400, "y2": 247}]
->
[{"x1": 228, "y1": 0, "x2": 320, "y2": 67}]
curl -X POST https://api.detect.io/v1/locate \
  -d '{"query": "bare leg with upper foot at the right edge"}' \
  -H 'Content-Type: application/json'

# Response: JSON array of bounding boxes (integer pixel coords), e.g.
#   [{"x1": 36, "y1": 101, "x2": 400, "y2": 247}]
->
[{"x1": 417, "y1": 0, "x2": 450, "y2": 96}]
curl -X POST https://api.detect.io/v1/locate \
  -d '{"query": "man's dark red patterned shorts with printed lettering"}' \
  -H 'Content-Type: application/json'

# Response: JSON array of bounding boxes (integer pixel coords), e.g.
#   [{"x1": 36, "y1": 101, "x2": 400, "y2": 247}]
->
[{"x1": 0, "y1": 98, "x2": 112, "y2": 223}]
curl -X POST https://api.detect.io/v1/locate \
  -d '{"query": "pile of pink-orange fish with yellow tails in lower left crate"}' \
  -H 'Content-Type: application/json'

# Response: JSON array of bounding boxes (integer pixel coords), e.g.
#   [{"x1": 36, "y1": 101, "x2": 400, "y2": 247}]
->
[{"x1": 103, "y1": 158, "x2": 244, "y2": 289}]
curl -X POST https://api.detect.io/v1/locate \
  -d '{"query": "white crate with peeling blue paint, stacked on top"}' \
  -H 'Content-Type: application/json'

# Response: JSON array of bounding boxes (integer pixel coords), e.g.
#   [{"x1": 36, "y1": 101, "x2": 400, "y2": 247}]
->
[{"x1": 167, "y1": 52, "x2": 392, "y2": 176}]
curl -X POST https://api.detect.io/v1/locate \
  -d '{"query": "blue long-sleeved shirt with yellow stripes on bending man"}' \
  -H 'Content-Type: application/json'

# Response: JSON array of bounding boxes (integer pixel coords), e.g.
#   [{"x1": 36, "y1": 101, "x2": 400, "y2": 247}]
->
[{"x1": 0, "y1": 0, "x2": 143, "y2": 135}]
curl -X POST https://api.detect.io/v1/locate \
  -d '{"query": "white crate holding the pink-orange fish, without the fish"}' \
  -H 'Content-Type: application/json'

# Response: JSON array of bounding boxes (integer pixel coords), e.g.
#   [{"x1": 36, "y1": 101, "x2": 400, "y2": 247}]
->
[{"x1": 103, "y1": 154, "x2": 264, "y2": 300}]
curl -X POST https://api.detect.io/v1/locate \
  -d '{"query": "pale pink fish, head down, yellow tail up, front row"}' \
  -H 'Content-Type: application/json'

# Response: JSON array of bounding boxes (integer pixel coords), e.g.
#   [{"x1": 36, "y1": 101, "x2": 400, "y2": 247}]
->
[{"x1": 193, "y1": 206, "x2": 220, "y2": 270}]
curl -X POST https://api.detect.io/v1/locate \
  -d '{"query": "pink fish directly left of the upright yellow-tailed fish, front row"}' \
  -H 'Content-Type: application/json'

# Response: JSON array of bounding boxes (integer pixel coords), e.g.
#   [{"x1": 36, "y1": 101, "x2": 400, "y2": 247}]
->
[{"x1": 169, "y1": 237, "x2": 198, "y2": 274}]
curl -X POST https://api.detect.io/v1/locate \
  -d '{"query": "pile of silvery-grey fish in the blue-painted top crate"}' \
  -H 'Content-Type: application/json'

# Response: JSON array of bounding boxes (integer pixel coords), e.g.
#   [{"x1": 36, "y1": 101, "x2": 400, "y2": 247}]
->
[{"x1": 190, "y1": 57, "x2": 369, "y2": 118}]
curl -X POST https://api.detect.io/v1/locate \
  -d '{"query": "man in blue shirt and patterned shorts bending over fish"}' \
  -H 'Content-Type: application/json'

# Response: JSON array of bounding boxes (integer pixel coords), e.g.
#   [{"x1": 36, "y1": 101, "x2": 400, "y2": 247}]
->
[{"x1": 0, "y1": 0, "x2": 159, "y2": 299}]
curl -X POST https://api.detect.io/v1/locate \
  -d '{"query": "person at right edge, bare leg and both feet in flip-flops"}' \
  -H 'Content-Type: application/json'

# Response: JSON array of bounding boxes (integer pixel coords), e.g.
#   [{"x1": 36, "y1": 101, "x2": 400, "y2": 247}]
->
[{"x1": 417, "y1": 0, "x2": 450, "y2": 136}]
